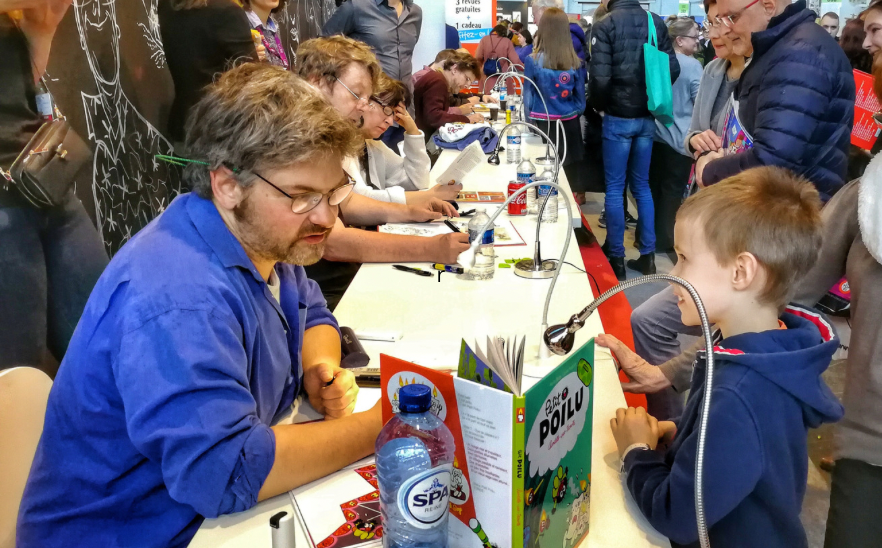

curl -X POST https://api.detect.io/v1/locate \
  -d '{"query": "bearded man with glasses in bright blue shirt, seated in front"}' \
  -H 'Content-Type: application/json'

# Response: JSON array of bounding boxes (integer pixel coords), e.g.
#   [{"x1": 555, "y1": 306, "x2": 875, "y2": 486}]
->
[{"x1": 18, "y1": 63, "x2": 382, "y2": 546}]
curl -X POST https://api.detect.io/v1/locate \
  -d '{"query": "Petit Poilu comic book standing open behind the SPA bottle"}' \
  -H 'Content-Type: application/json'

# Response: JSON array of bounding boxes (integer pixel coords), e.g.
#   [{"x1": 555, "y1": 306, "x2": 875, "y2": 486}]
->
[{"x1": 381, "y1": 339, "x2": 594, "y2": 548}]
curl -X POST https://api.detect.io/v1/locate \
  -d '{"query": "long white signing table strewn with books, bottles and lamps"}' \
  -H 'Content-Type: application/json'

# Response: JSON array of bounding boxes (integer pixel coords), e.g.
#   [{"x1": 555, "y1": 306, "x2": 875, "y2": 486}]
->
[{"x1": 190, "y1": 139, "x2": 670, "y2": 548}]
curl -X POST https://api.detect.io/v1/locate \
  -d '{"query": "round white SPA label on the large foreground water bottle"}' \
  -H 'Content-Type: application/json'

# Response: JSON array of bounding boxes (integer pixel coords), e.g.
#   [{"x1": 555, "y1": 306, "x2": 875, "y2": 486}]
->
[{"x1": 398, "y1": 464, "x2": 450, "y2": 529}]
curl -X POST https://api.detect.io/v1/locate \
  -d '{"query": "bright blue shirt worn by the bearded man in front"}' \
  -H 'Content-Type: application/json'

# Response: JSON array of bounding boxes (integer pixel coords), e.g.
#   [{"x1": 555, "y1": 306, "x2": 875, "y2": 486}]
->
[{"x1": 18, "y1": 194, "x2": 337, "y2": 547}]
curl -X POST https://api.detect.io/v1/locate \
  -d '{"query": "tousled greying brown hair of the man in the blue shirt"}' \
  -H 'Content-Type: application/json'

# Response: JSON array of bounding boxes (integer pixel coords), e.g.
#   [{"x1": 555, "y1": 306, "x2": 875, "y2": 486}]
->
[{"x1": 184, "y1": 63, "x2": 364, "y2": 198}]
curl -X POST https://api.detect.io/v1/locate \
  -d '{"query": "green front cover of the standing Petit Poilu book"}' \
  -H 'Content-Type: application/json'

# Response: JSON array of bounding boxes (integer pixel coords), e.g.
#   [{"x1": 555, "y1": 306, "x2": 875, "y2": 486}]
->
[{"x1": 515, "y1": 339, "x2": 594, "y2": 548}]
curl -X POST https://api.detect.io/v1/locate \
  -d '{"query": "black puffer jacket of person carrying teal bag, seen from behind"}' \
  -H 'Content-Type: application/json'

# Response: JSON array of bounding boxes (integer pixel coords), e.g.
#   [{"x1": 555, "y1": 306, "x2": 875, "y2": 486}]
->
[{"x1": 588, "y1": 0, "x2": 680, "y2": 118}]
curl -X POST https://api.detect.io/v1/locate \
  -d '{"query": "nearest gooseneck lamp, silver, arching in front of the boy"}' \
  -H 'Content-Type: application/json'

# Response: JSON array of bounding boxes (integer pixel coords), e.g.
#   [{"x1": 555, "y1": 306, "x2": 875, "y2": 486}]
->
[{"x1": 543, "y1": 274, "x2": 714, "y2": 548}]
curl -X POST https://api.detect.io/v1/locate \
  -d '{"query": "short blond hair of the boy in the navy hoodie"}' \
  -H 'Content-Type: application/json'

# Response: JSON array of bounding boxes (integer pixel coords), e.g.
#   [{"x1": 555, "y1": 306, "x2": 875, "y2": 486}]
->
[{"x1": 677, "y1": 167, "x2": 822, "y2": 308}]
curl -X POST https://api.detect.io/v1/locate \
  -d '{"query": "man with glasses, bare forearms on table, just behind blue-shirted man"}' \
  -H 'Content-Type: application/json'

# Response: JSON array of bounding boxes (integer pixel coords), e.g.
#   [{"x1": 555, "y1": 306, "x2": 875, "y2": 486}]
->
[{"x1": 297, "y1": 36, "x2": 468, "y2": 310}]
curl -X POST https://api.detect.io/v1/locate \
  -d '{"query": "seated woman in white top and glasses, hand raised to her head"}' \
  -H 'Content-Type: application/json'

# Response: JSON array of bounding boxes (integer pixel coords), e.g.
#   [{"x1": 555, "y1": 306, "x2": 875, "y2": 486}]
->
[{"x1": 343, "y1": 73, "x2": 462, "y2": 205}]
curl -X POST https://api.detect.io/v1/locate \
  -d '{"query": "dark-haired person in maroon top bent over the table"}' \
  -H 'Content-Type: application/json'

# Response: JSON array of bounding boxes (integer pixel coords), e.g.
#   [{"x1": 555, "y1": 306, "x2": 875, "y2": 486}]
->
[{"x1": 413, "y1": 53, "x2": 484, "y2": 142}]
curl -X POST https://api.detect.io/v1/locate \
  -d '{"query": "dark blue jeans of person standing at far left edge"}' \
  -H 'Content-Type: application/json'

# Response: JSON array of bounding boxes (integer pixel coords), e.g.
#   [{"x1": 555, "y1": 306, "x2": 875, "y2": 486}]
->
[{"x1": 0, "y1": 188, "x2": 108, "y2": 377}]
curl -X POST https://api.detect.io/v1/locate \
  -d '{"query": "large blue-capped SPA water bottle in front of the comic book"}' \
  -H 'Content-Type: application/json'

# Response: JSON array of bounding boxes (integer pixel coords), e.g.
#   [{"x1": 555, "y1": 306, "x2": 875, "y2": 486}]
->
[{"x1": 376, "y1": 384, "x2": 455, "y2": 548}]
